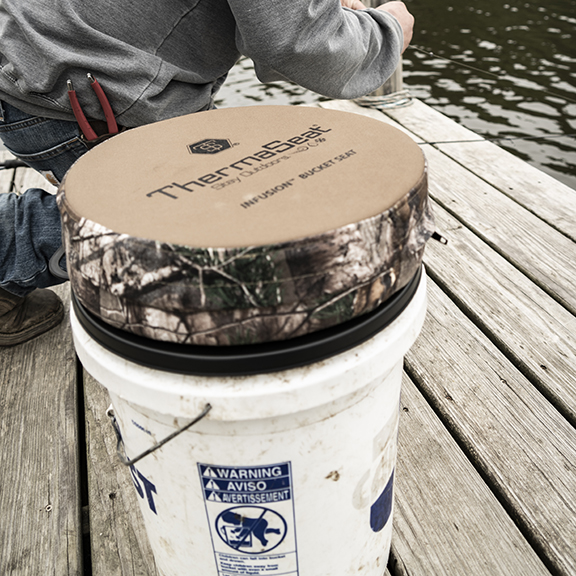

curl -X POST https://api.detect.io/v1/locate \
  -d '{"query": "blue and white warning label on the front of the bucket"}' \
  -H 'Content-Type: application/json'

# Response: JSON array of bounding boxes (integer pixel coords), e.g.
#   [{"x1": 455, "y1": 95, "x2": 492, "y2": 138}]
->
[{"x1": 198, "y1": 462, "x2": 298, "y2": 576}]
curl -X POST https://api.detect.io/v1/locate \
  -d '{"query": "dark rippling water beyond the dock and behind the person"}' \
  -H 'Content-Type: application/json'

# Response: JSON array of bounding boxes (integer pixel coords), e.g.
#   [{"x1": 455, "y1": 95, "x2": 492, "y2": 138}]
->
[{"x1": 218, "y1": 0, "x2": 576, "y2": 194}]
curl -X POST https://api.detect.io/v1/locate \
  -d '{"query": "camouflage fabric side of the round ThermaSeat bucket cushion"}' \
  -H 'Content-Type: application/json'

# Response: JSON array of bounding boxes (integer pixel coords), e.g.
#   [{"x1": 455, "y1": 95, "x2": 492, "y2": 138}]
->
[{"x1": 58, "y1": 171, "x2": 433, "y2": 345}]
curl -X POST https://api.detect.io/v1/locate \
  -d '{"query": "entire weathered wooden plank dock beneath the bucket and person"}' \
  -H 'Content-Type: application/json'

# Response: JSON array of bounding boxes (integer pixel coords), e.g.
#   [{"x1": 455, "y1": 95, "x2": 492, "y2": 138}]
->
[{"x1": 0, "y1": 101, "x2": 576, "y2": 576}]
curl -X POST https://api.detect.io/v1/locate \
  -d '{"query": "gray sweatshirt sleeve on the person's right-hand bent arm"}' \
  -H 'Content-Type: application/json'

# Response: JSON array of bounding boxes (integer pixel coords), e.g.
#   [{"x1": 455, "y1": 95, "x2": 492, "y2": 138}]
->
[{"x1": 228, "y1": 0, "x2": 403, "y2": 99}]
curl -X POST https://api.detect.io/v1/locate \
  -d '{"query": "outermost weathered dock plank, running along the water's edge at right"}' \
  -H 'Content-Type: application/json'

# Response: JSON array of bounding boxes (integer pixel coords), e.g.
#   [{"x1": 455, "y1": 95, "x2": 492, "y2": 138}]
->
[{"x1": 386, "y1": 100, "x2": 576, "y2": 240}]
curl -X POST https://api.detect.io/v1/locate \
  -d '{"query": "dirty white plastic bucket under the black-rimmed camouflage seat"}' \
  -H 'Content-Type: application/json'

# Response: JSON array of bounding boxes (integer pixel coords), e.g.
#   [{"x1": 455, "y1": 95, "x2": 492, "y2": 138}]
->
[{"x1": 72, "y1": 273, "x2": 426, "y2": 576}]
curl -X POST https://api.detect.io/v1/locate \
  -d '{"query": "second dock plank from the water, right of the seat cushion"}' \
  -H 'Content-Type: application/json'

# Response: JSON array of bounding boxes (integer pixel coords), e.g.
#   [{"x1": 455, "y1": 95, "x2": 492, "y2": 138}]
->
[{"x1": 322, "y1": 102, "x2": 576, "y2": 314}]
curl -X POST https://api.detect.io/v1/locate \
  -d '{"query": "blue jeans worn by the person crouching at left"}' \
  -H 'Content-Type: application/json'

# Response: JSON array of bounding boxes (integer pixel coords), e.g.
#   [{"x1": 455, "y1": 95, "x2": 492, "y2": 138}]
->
[{"x1": 0, "y1": 102, "x2": 88, "y2": 296}]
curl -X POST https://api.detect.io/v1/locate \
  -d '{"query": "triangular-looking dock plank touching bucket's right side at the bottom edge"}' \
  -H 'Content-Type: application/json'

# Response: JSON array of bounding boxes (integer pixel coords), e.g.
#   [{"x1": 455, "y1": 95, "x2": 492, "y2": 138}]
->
[{"x1": 390, "y1": 377, "x2": 548, "y2": 576}]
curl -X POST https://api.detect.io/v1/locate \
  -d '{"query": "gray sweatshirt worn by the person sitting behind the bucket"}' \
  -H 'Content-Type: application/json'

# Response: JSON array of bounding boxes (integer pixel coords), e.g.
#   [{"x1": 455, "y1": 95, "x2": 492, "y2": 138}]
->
[{"x1": 0, "y1": 0, "x2": 402, "y2": 127}]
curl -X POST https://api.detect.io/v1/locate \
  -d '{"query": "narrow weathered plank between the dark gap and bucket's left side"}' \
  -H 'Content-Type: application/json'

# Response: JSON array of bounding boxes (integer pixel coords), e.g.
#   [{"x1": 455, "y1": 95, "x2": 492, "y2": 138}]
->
[{"x1": 84, "y1": 372, "x2": 157, "y2": 576}]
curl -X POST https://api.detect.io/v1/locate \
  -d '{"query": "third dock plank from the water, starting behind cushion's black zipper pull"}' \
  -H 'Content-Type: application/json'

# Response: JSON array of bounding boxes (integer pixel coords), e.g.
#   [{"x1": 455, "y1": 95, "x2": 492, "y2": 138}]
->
[{"x1": 424, "y1": 201, "x2": 576, "y2": 426}]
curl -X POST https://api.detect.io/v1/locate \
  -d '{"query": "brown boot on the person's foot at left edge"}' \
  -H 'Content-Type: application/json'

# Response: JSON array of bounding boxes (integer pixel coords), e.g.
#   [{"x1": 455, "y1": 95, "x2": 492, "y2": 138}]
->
[{"x1": 0, "y1": 288, "x2": 64, "y2": 346}]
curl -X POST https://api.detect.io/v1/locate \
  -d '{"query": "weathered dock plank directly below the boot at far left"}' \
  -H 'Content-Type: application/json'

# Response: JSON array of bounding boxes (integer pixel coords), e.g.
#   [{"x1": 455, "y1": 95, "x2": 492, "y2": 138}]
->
[{"x1": 0, "y1": 284, "x2": 82, "y2": 576}]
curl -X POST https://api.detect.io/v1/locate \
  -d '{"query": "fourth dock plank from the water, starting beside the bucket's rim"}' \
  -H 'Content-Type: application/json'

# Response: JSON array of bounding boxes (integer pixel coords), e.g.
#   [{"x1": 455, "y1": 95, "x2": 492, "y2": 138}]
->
[{"x1": 406, "y1": 282, "x2": 576, "y2": 574}]
